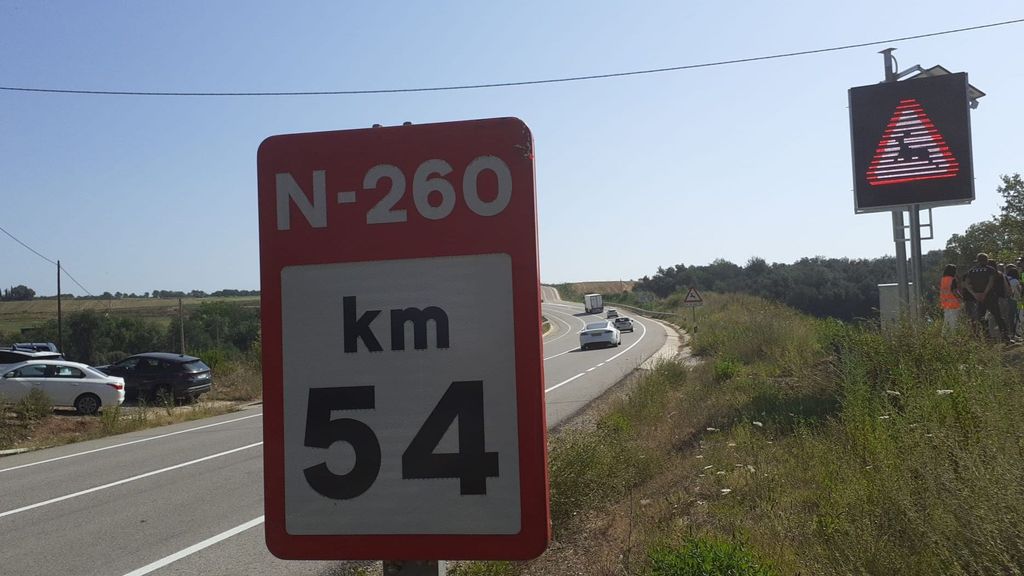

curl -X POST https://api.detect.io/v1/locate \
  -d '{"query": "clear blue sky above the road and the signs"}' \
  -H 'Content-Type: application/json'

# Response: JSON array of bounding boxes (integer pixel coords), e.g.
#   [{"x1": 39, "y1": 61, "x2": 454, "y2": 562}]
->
[{"x1": 0, "y1": 0, "x2": 1024, "y2": 294}]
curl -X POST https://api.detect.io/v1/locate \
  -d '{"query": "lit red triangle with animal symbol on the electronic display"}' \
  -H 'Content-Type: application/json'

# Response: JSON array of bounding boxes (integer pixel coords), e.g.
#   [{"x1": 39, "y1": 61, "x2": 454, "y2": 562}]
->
[{"x1": 867, "y1": 98, "x2": 959, "y2": 186}]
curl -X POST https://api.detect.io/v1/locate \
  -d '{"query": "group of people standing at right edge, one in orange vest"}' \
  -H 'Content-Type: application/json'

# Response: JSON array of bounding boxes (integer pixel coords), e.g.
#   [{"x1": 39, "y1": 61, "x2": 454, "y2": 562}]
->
[{"x1": 939, "y1": 253, "x2": 1024, "y2": 343}]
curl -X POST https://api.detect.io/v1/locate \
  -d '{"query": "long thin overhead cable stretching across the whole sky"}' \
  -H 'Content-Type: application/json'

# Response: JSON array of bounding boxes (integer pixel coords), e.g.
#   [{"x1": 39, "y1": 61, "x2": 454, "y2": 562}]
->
[{"x1": 0, "y1": 18, "x2": 1024, "y2": 96}]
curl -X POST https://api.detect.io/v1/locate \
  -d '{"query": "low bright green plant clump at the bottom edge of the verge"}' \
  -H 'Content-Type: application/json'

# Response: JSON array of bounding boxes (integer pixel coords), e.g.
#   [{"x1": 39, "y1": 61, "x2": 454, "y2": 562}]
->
[{"x1": 648, "y1": 538, "x2": 777, "y2": 576}]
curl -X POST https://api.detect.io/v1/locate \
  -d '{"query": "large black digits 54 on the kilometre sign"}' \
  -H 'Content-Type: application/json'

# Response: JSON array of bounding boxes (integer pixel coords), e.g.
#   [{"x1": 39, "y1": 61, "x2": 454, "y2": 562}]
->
[{"x1": 303, "y1": 380, "x2": 498, "y2": 500}]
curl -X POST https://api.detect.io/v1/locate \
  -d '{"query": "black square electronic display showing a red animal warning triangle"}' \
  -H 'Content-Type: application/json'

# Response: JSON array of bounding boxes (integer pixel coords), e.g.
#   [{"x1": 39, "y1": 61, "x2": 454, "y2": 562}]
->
[{"x1": 850, "y1": 73, "x2": 974, "y2": 212}]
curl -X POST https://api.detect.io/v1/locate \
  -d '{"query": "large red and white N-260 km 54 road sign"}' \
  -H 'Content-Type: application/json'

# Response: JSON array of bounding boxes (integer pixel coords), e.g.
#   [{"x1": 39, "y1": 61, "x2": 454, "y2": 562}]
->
[{"x1": 258, "y1": 118, "x2": 550, "y2": 560}]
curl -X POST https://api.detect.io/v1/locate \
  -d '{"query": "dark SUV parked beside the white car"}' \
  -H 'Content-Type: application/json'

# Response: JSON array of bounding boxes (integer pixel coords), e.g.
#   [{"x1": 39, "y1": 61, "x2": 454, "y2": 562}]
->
[{"x1": 96, "y1": 352, "x2": 213, "y2": 400}]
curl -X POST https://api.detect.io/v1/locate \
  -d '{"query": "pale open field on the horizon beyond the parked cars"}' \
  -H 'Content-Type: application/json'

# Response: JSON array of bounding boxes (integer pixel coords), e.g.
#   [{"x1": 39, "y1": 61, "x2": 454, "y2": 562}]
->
[{"x1": 0, "y1": 296, "x2": 259, "y2": 332}]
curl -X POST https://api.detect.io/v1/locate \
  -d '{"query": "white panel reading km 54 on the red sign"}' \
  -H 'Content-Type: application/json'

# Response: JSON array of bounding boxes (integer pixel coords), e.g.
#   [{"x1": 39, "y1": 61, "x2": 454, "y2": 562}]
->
[{"x1": 281, "y1": 254, "x2": 520, "y2": 535}]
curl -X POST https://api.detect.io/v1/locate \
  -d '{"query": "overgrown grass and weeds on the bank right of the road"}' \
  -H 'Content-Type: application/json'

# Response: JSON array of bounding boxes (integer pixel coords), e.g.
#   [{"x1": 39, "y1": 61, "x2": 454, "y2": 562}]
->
[{"x1": 454, "y1": 294, "x2": 1024, "y2": 576}]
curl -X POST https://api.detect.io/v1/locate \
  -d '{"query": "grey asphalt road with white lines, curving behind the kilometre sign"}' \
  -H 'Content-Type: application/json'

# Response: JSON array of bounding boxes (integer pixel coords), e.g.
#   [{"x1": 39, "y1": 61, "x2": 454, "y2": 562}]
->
[{"x1": 0, "y1": 288, "x2": 666, "y2": 576}]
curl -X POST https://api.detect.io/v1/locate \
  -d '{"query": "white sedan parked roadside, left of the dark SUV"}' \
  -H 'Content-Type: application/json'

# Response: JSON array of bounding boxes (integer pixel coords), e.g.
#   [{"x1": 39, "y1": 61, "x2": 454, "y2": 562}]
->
[{"x1": 0, "y1": 360, "x2": 125, "y2": 414}]
